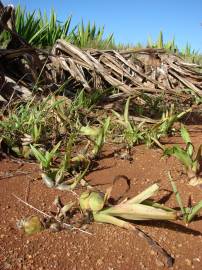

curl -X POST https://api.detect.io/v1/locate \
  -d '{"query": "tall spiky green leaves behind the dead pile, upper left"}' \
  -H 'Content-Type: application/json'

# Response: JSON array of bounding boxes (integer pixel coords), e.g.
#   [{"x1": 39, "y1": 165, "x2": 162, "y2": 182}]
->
[{"x1": 0, "y1": 5, "x2": 114, "y2": 48}]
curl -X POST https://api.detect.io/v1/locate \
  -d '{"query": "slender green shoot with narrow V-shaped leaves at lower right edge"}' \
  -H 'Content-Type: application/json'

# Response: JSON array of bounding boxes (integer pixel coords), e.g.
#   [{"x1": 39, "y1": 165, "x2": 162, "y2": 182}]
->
[{"x1": 168, "y1": 172, "x2": 202, "y2": 223}]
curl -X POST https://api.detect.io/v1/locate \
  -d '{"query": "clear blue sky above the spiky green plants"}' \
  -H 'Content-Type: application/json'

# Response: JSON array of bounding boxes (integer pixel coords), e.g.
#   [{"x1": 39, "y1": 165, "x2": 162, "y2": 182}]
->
[{"x1": 3, "y1": 0, "x2": 202, "y2": 52}]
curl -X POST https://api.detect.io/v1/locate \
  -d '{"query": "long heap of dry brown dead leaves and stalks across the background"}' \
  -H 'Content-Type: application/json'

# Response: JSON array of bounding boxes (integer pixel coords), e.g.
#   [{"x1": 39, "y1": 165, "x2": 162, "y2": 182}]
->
[{"x1": 0, "y1": 2, "x2": 202, "y2": 106}]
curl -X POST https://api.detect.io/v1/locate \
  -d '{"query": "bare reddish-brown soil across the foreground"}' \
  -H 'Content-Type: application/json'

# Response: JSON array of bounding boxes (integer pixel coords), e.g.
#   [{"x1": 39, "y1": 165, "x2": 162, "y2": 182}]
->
[{"x1": 0, "y1": 125, "x2": 202, "y2": 270}]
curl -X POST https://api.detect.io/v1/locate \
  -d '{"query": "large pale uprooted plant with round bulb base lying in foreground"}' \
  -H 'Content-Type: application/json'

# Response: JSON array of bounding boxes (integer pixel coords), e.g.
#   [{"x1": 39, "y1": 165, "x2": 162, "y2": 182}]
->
[{"x1": 79, "y1": 184, "x2": 177, "y2": 267}]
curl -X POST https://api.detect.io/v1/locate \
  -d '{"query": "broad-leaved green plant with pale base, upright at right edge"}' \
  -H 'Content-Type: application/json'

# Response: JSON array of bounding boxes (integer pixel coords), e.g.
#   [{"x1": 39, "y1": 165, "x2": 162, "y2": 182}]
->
[{"x1": 164, "y1": 126, "x2": 202, "y2": 186}]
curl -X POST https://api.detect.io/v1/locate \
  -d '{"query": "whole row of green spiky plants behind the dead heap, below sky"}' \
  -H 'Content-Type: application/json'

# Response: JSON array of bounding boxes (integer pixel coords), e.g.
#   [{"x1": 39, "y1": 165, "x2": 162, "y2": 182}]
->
[{"x1": 0, "y1": 6, "x2": 202, "y2": 63}]
